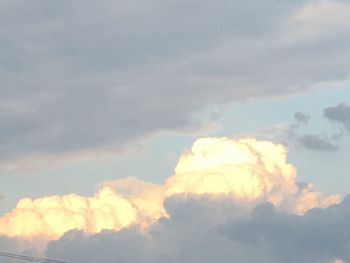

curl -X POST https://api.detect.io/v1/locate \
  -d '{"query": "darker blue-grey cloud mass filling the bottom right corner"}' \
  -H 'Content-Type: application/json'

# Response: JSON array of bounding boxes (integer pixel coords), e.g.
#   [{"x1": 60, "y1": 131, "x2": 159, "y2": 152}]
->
[{"x1": 221, "y1": 198, "x2": 350, "y2": 262}]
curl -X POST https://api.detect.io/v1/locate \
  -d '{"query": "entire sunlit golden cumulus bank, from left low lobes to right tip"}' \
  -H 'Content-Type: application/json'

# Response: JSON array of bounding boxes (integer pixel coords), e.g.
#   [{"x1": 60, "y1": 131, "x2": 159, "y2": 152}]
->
[{"x1": 0, "y1": 137, "x2": 340, "y2": 240}]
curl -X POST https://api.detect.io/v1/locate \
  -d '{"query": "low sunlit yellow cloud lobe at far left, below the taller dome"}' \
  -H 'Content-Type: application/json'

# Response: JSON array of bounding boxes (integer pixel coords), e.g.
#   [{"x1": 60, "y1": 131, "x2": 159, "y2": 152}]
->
[{"x1": 0, "y1": 188, "x2": 142, "y2": 239}]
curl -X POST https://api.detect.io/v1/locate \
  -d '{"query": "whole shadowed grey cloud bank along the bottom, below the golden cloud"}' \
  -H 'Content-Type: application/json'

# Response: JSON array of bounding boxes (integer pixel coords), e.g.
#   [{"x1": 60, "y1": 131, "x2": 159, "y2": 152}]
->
[{"x1": 46, "y1": 197, "x2": 350, "y2": 263}]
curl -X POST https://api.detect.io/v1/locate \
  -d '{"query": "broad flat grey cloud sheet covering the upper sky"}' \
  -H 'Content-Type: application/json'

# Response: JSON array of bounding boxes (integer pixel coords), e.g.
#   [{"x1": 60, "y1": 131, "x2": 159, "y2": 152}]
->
[{"x1": 0, "y1": 0, "x2": 350, "y2": 173}]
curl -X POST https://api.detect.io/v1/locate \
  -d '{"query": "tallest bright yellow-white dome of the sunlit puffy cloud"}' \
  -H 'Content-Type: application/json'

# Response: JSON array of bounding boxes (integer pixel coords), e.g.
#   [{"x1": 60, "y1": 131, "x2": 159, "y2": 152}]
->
[{"x1": 167, "y1": 138, "x2": 298, "y2": 203}]
